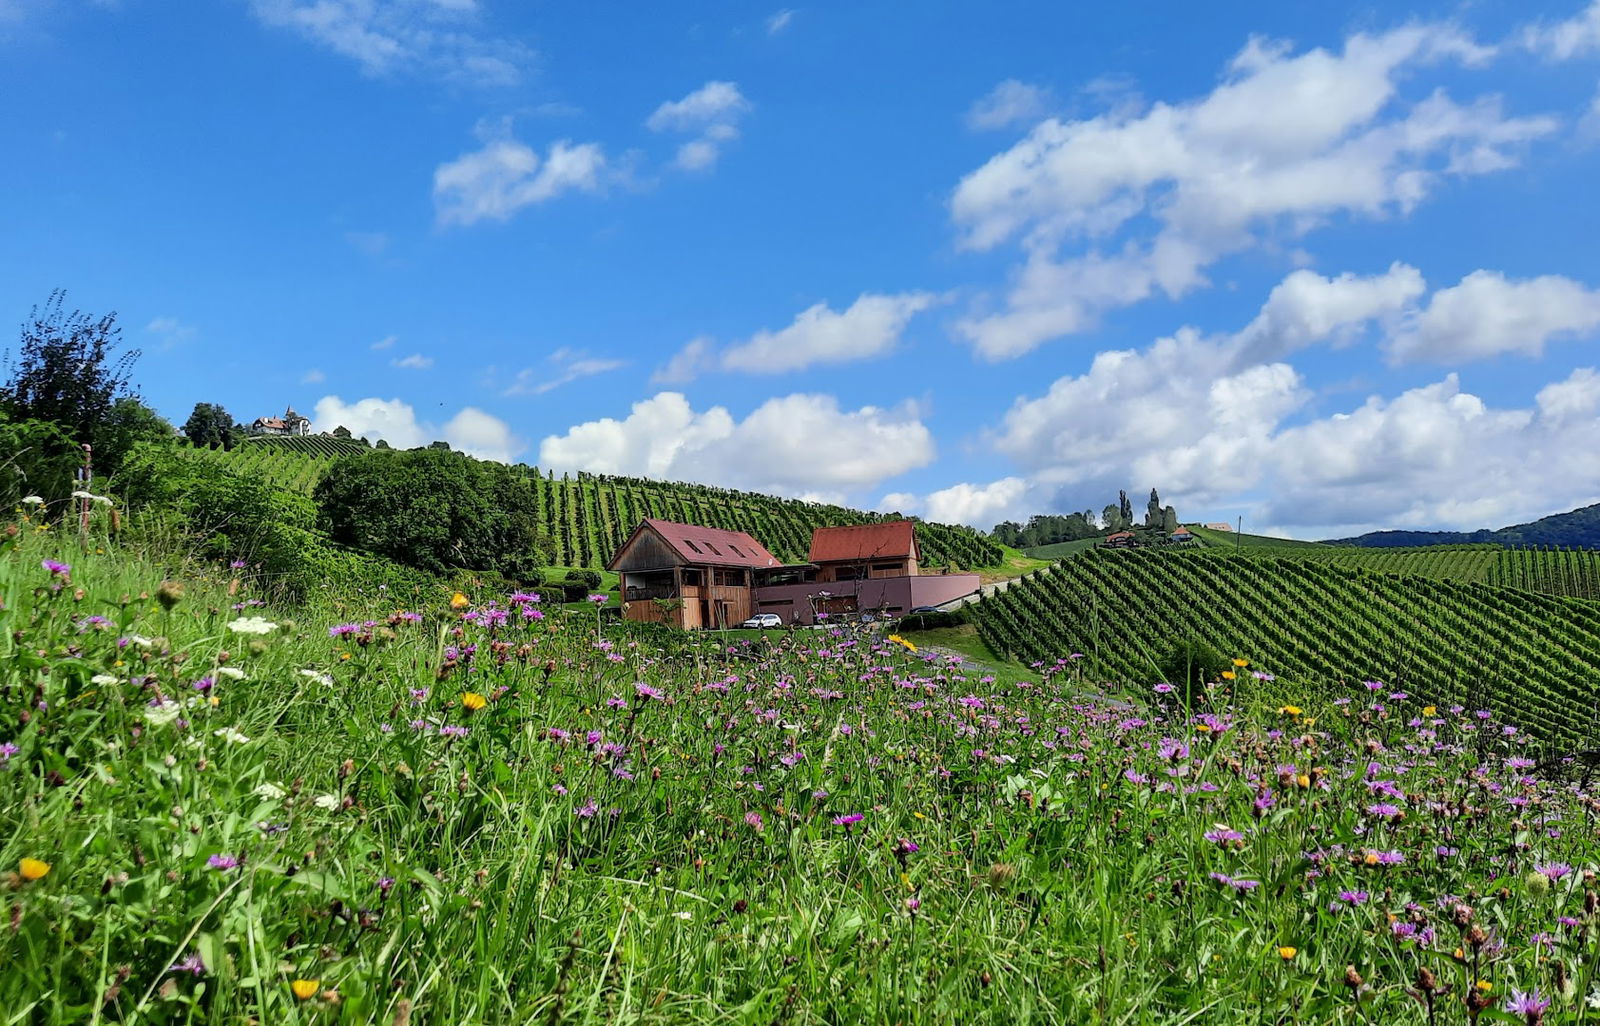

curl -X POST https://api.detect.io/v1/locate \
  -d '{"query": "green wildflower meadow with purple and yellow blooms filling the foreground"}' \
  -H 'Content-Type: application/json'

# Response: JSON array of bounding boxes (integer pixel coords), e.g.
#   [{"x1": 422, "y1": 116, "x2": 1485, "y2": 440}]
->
[{"x1": 0, "y1": 530, "x2": 1600, "y2": 1026}]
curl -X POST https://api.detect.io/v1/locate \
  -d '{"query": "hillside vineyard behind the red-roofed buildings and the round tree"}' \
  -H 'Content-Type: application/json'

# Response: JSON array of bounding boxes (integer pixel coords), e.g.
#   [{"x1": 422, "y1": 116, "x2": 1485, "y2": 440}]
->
[{"x1": 197, "y1": 435, "x2": 1005, "y2": 570}]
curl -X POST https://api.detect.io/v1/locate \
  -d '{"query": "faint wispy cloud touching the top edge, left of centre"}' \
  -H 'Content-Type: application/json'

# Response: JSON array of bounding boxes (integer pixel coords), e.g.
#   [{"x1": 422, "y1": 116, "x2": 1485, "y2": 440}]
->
[{"x1": 250, "y1": 0, "x2": 534, "y2": 88}]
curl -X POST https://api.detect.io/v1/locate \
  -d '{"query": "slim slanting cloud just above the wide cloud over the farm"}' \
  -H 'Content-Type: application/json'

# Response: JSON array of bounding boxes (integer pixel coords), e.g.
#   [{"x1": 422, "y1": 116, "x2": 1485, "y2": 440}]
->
[{"x1": 654, "y1": 291, "x2": 939, "y2": 384}]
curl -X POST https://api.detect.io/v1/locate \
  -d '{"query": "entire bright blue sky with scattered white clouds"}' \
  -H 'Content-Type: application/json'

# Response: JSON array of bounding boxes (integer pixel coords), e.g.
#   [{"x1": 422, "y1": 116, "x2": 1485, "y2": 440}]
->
[{"x1": 0, "y1": 0, "x2": 1600, "y2": 536}]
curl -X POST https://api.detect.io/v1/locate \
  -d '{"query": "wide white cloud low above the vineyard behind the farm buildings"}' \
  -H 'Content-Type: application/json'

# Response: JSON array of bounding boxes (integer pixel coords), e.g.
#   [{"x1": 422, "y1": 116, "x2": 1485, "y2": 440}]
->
[{"x1": 539, "y1": 392, "x2": 934, "y2": 498}]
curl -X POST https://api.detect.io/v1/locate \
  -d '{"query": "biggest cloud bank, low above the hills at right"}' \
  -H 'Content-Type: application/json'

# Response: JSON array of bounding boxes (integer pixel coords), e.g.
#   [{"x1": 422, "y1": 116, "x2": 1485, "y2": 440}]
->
[{"x1": 985, "y1": 264, "x2": 1600, "y2": 536}]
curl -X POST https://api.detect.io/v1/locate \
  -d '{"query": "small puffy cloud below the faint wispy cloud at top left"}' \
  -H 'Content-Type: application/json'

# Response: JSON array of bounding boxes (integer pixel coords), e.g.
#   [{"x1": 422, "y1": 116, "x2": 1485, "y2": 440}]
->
[{"x1": 434, "y1": 139, "x2": 606, "y2": 224}]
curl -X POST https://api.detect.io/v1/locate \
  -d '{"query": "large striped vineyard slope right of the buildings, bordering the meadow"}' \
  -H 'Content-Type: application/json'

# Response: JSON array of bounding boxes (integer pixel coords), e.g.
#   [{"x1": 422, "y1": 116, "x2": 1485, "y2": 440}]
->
[{"x1": 973, "y1": 551, "x2": 1600, "y2": 743}]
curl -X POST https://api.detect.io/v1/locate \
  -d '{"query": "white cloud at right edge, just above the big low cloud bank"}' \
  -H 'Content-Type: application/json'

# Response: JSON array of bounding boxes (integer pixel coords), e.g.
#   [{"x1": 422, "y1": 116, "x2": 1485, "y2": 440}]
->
[{"x1": 1389, "y1": 271, "x2": 1600, "y2": 363}]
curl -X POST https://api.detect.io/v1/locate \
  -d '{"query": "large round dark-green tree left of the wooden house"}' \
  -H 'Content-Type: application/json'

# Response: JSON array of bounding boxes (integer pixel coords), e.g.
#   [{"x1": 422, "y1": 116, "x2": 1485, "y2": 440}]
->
[{"x1": 315, "y1": 448, "x2": 549, "y2": 578}]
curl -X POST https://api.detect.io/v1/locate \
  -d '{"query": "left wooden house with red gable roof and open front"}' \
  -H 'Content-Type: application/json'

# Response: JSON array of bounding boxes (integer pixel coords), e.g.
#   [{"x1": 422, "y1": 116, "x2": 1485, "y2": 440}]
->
[{"x1": 606, "y1": 519, "x2": 779, "y2": 627}]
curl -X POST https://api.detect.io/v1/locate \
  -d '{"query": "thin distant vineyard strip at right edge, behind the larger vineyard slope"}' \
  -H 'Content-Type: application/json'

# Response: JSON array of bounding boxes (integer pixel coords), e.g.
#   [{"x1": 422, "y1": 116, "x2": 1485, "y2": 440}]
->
[{"x1": 1186, "y1": 543, "x2": 1600, "y2": 599}]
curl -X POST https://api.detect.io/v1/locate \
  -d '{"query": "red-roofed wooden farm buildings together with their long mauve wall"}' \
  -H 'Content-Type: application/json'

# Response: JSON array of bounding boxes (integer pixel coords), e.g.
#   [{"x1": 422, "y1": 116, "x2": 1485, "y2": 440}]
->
[{"x1": 606, "y1": 519, "x2": 979, "y2": 627}]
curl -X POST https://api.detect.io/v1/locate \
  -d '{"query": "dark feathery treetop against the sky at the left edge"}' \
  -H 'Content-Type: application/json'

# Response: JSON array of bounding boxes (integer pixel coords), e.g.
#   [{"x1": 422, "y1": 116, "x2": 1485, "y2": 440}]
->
[{"x1": 0, "y1": 288, "x2": 139, "y2": 443}]
